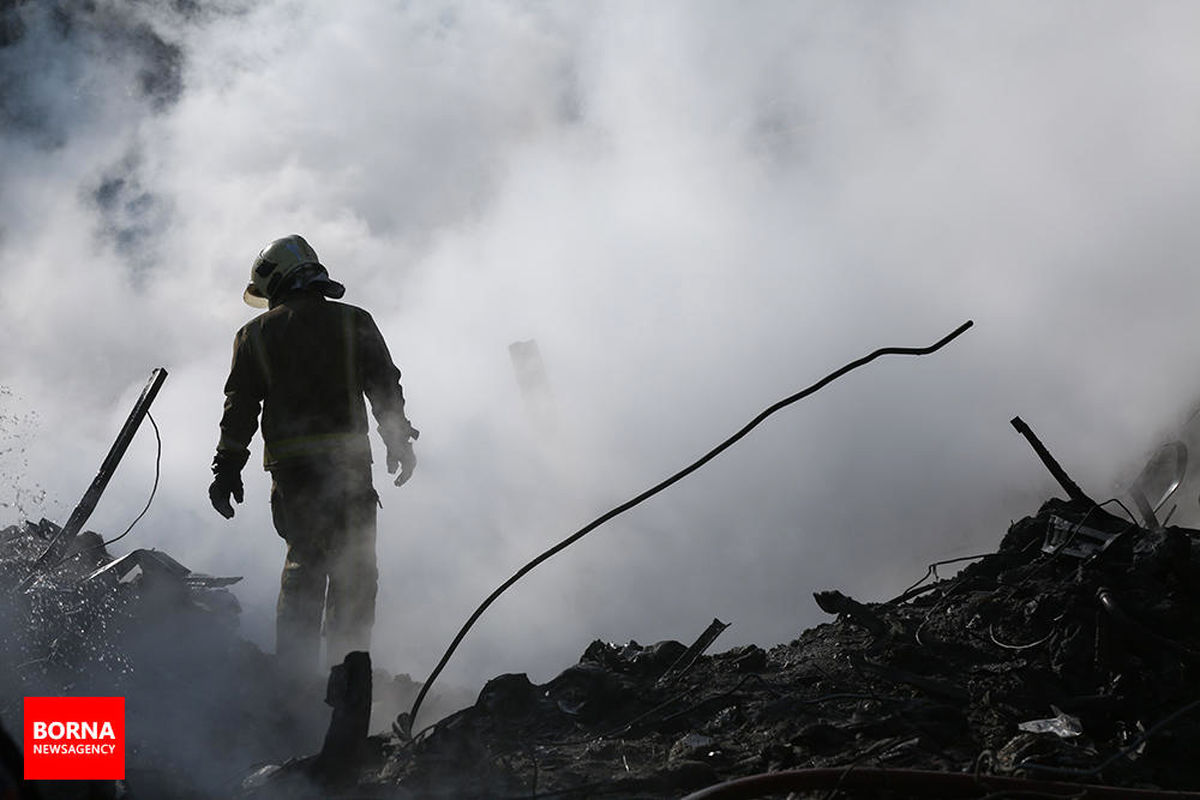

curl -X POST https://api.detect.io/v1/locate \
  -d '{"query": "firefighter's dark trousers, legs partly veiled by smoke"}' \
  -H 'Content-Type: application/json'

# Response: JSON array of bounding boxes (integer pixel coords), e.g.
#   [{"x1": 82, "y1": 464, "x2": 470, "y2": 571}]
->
[{"x1": 271, "y1": 461, "x2": 379, "y2": 672}]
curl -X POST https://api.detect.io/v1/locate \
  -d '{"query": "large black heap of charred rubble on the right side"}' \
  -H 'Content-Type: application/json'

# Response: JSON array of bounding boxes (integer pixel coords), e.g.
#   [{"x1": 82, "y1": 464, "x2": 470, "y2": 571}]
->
[{"x1": 242, "y1": 500, "x2": 1200, "y2": 799}]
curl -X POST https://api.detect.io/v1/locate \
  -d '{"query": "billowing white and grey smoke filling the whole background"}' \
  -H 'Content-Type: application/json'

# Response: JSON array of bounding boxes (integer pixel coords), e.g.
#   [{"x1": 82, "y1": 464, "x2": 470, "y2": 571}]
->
[{"x1": 0, "y1": 0, "x2": 1200, "y2": 714}]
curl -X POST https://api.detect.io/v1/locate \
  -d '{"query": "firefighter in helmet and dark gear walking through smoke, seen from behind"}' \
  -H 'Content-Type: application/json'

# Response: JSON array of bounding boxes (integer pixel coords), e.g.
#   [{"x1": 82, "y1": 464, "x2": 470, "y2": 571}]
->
[{"x1": 209, "y1": 234, "x2": 418, "y2": 672}]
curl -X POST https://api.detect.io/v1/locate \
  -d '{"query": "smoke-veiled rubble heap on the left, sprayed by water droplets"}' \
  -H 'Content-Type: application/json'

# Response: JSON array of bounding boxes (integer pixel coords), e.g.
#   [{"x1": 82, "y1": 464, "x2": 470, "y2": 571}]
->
[{"x1": 0, "y1": 519, "x2": 333, "y2": 798}]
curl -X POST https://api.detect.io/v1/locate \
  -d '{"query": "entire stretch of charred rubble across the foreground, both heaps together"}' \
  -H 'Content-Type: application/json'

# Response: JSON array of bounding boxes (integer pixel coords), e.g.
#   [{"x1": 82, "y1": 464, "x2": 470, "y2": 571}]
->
[{"x1": 0, "y1": 359, "x2": 1200, "y2": 800}]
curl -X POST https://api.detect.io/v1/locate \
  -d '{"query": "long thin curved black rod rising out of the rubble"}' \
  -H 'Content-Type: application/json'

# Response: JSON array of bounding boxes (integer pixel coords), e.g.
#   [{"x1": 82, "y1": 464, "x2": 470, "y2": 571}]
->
[{"x1": 407, "y1": 319, "x2": 974, "y2": 729}]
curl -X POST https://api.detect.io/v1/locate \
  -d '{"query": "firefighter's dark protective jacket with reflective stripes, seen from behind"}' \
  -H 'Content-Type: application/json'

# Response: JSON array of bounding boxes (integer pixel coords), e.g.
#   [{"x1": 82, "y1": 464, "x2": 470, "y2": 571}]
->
[{"x1": 212, "y1": 289, "x2": 413, "y2": 474}]
